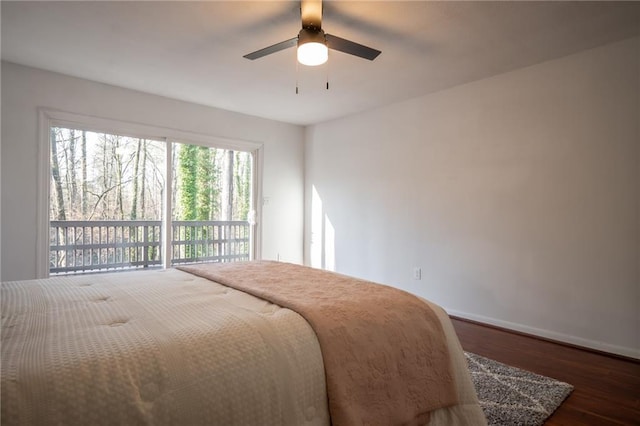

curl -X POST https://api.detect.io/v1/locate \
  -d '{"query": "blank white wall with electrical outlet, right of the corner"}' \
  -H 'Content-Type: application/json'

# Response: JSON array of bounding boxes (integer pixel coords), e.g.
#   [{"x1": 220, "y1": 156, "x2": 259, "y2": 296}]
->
[{"x1": 305, "y1": 38, "x2": 640, "y2": 357}]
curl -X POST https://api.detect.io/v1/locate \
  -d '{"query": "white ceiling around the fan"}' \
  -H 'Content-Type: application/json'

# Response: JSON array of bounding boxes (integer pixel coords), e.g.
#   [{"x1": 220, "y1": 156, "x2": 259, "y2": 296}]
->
[{"x1": 0, "y1": 1, "x2": 640, "y2": 125}]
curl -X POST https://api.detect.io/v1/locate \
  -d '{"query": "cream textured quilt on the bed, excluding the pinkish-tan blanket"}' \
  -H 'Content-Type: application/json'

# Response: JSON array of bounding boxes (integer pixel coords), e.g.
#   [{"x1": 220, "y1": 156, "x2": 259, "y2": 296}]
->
[{"x1": 1, "y1": 269, "x2": 485, "y2": 425}]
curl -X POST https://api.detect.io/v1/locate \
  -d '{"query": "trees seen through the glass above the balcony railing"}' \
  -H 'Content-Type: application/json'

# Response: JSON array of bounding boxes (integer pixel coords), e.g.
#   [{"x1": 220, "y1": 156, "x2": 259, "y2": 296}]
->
[{"x1": 50, "y1": 128, "x2": 252, "y2": 226}]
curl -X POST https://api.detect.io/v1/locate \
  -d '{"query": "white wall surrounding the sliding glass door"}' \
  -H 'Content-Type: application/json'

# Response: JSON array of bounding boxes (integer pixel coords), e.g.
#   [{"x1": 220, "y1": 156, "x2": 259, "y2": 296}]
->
[{"x1": 0, "y1": 62, "x2": 304, "y2": 280}]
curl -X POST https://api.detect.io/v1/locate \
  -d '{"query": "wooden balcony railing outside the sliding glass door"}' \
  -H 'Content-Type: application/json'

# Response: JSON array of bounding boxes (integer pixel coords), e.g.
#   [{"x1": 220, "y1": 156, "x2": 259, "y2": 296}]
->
[{"x1": 49, "y1": 220, "x2": 250, "y2": 274}]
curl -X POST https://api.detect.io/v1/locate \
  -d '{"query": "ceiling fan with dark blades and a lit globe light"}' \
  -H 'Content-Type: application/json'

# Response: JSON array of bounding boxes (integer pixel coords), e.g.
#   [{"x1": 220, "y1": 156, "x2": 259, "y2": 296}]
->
[{"x1": 244, "y1": 0, "x2": 381, "y2": 66}]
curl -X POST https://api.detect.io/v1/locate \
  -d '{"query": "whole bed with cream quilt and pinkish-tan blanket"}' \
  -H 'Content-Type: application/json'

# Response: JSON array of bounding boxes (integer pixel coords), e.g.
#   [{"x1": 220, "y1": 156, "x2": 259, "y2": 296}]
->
[{"x1": 1, "y1": 262, "x2": 486, "y2": 426}]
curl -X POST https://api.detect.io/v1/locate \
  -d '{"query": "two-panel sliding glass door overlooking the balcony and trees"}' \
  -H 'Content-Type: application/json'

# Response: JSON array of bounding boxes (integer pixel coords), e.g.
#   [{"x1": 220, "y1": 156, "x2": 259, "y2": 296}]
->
[{"x1": 48, "y1": 126, "x2": 255, "y2": 274}]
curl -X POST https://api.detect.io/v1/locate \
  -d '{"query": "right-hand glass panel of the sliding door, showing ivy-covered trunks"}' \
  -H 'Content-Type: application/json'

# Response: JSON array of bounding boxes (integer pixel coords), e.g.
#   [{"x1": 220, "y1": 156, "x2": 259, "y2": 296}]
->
[{"x1": 171, "y1": 143, "x2": 253, "y2": 264}]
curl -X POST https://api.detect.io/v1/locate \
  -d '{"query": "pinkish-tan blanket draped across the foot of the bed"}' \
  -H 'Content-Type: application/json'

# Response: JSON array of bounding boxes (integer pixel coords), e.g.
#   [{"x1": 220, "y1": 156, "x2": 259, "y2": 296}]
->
[{"x1": 179, "y1": 261, "x2": 457, "y2": 426}]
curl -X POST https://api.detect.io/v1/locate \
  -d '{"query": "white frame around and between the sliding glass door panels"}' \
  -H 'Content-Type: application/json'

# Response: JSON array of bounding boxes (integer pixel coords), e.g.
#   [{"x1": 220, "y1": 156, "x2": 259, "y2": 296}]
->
[{"x1": 36, "y1": 108, "x2": 263, "y2": 278}]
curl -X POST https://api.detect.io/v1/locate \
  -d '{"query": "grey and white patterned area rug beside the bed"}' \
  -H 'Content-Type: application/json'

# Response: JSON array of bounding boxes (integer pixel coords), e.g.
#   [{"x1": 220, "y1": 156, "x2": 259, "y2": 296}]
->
[{"x1": 465, "y1": 352, "x2": 573, "y2": 426}]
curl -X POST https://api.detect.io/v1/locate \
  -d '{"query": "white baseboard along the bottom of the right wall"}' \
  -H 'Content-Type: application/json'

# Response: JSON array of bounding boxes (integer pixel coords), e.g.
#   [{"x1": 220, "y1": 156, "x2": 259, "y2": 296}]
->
[{"x1": 445, "y1": 308, "x2": 640, "y2": 360}]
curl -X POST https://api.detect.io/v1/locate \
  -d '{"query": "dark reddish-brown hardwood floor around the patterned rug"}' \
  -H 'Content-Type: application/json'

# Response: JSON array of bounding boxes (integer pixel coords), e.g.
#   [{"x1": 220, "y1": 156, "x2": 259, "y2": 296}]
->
[{"x1": 452, "y1": 318, "x2": 640, "y2": 426}]
